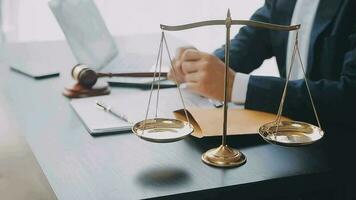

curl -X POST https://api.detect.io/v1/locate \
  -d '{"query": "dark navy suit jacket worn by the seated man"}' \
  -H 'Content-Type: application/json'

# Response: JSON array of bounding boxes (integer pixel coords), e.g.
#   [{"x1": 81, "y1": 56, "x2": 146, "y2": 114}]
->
[{"x1": 215, "y1": 0, "x2": 356, "y2": 128}]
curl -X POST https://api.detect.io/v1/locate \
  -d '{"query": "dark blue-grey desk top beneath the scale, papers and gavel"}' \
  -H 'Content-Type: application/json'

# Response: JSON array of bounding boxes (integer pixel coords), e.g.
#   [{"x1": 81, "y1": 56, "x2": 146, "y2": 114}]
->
[{"x1": 0, "y1": 36, "x2": 331, "y2": 200}]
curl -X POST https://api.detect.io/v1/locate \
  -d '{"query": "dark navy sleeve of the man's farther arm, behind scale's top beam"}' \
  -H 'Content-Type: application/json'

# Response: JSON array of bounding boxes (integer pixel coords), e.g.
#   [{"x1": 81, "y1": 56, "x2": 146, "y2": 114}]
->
[{"x1": 214, "y1": 0, "x2": 273, "y2": 74}]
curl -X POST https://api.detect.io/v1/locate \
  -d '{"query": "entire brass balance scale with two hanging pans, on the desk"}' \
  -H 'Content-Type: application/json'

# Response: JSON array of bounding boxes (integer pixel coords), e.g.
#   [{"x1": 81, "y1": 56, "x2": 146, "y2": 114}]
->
[{"x1": 132, "y1": 10, "x2": 324, "y2": 167}]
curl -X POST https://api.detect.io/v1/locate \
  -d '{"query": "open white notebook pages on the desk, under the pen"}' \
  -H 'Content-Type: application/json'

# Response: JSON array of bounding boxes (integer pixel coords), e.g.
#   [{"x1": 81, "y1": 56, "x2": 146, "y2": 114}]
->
[{"x1": 70, "y1": 88, "x2": 214, "y2": 136}]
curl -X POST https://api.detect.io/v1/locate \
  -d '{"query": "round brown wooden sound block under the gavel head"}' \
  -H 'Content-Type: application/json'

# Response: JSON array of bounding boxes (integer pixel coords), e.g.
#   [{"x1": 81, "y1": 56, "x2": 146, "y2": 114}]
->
[{"x1": 62, "y1": 81, "x2": 110, "y2": 98}]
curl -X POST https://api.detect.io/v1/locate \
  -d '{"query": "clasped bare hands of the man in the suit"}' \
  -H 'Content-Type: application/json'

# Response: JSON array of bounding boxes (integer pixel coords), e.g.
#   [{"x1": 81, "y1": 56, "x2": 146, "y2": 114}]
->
[{"x1": 168, "y1": 48, "x2": 235, "y2": 101}]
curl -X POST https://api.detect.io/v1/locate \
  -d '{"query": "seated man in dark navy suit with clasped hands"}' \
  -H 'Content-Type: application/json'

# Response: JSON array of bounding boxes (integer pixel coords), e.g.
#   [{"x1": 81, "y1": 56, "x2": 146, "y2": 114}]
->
[{"x1": 169, "y1": 0, "x2": 356, "y2": 129}]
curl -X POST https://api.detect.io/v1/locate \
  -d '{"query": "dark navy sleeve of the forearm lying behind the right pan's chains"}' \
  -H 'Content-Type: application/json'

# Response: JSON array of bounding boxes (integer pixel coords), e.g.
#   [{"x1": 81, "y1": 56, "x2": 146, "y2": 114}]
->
[{"x1": 245, "y1": 33, "x2": 356, "y2": 126}]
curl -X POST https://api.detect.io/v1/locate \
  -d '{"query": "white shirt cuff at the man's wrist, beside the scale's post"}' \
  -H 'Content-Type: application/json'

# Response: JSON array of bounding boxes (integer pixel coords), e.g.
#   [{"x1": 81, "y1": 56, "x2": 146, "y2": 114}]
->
[{"x1": 231, "y1": 72, "x2": 250, "y2": 104}]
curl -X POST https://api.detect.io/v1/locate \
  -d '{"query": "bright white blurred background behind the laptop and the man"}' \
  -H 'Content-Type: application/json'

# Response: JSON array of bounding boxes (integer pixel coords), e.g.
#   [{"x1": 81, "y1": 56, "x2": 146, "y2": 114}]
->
[{"x1": 0, "y1": 0, "x2": 278, "y2": 75}]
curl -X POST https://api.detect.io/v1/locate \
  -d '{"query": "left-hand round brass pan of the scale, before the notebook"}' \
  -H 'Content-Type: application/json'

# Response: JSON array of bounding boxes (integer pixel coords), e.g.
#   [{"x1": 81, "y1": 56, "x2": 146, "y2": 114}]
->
[{"x1": 132, "y1": 118, "x2": 194, "y2": 143}]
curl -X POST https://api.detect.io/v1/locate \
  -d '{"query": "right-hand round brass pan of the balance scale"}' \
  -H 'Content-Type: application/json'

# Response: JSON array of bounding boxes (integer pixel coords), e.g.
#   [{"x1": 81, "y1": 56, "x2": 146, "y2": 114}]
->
[{"x1": 259, "y1": 121, "x2": 324, "y2": 147}]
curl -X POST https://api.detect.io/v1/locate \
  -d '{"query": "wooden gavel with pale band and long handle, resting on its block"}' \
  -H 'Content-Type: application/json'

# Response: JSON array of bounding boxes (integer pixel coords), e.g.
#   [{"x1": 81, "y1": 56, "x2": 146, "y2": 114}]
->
[{"x1": 72, "y1": 64, "x2": 168, "y2": 89}]
